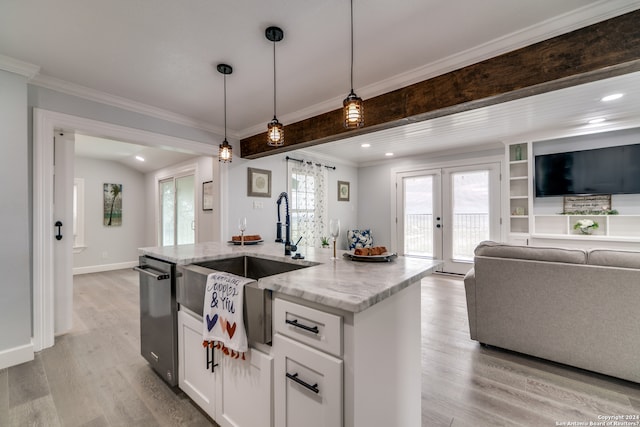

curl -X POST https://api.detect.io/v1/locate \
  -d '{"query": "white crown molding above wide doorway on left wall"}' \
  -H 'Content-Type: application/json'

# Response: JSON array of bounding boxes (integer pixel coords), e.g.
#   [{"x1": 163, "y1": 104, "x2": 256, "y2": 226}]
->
[{"x1": 30, "y1": 74, "x2": 237, "y2": 138}]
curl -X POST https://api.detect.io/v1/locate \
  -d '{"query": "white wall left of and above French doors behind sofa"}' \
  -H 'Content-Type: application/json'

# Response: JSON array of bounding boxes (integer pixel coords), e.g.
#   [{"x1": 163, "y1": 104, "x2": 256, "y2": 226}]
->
[{"x1": 356, "y1": 147, "x2": 504, "y2": 250}]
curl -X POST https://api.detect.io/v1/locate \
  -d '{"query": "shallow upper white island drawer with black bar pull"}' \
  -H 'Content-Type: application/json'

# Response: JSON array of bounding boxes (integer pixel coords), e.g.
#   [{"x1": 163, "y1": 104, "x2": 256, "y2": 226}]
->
[{"x1": 273, "y1": 298, "x2": 342, "y2": 357}]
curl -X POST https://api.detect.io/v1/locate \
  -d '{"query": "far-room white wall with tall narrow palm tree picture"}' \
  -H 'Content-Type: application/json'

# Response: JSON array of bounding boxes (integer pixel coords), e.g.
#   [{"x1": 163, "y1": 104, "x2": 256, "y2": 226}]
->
[{"x1": 73, "y1": 157, "x2": 147, "y2": 273}]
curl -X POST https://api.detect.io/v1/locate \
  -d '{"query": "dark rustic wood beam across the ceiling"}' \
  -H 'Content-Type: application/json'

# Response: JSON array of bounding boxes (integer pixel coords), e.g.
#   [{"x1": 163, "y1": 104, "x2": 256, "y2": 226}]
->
[{"x1": 240, "y1": 10, "x2": 640, "y2": 159}]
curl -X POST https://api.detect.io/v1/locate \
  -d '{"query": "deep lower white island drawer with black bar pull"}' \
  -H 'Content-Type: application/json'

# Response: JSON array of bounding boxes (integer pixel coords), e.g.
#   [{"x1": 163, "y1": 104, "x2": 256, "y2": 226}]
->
[{"x1": 273, "y1": 334, "x2": 343, "y2": 427}]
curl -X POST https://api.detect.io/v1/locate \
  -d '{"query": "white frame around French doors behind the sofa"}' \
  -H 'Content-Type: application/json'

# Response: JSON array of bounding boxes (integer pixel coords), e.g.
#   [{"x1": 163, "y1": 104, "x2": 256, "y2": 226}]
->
[{"x1": 389, "y1": 157, "x2": 505, "y2": 270}]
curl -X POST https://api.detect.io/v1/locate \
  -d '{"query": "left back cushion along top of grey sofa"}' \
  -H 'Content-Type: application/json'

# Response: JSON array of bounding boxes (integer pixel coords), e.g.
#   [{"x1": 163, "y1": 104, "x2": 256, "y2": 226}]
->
[{"x1": 474, "y1": 241, "x2": 587, "y2": 264}]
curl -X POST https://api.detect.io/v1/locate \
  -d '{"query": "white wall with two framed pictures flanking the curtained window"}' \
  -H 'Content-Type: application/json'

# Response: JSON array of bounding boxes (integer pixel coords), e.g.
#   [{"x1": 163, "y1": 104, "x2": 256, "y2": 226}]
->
[{"x1": 221, "y1": 150, "x2": 358, "y2": 251}]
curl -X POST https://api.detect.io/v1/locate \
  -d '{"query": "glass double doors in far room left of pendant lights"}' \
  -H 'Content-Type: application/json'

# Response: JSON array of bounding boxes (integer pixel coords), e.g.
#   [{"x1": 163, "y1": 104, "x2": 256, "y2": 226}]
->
[{"x1": 158, "y1": 173, "x2": 196, "y2": 246}]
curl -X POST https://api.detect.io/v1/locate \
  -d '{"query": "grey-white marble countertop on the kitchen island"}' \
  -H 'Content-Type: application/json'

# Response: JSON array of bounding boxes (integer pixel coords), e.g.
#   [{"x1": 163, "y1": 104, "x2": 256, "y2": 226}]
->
[{"x1": 139, "y1": 242, "x2": 440, "y2": 313}]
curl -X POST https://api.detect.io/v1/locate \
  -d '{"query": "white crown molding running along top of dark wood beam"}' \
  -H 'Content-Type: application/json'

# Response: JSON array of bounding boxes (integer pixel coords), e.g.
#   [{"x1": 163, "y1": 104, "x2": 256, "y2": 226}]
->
[{"x1": 239, "y1": 0, "x2": 638, "y2": 139}]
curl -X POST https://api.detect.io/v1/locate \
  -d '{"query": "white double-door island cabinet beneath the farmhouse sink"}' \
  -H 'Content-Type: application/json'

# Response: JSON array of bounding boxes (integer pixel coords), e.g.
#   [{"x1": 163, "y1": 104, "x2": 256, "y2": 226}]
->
[{"x1": 178, "y1": 309, "x2": 273, "y2": 427}]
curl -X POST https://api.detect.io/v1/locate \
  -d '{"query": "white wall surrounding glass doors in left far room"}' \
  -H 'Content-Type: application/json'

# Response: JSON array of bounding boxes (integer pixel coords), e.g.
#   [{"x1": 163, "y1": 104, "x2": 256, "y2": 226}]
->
[{"x1": 145, "y1": 156, "x2": 221, "y2": 247}]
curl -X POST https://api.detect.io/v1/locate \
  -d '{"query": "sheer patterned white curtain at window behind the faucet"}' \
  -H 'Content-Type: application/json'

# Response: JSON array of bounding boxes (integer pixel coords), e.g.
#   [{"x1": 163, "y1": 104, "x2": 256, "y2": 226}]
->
[{"x1": 288, "y1": 161, "x2": 328, "y2": 247}]
